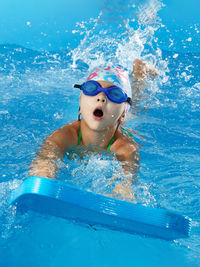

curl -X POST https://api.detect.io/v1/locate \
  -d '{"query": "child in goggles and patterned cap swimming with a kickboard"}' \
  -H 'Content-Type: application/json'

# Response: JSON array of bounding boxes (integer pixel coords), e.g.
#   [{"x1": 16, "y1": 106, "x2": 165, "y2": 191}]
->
[{"x1": 29, "y1": 59, "x2": 158, "y2": 199}]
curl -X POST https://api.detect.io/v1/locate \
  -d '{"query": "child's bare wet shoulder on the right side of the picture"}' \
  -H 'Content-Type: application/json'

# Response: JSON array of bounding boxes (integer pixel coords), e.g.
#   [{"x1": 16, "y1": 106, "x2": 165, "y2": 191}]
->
[{"x1": 110, "y1": 129, "x2": 139, "y2": 161}]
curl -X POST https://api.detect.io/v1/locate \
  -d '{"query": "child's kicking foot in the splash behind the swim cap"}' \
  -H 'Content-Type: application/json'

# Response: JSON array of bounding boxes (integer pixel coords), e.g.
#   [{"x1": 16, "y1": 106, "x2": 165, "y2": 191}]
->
[{"x1": 132, "y1": 59, "x2": 159, "y2": 81}]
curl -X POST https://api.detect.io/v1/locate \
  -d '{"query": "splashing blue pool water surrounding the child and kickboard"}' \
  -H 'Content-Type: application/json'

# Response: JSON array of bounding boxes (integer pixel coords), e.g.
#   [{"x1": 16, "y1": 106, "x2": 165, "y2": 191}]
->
[{"x1": 0, "y1": 1, "x2": 200, "y2": 267}]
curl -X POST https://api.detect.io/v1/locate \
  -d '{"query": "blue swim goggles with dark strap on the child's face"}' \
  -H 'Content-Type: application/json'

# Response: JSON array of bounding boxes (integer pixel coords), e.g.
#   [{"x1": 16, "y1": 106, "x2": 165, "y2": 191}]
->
[{"x1": 74, "y1": 80, "x2": 132, "y2": 106}]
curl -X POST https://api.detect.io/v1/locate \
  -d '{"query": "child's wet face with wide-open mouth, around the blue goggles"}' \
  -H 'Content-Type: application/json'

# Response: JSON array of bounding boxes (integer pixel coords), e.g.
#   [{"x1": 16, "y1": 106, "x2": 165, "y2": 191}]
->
[{"x1": 80, "y1": 81, "x2": 125, "y2": 131}]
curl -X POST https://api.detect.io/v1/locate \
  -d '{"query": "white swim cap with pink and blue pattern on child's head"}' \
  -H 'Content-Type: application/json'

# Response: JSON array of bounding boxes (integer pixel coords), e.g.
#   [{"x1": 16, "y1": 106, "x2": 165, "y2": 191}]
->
[{"x1": 87, "y1": 63, "x2": 132, "y2": 112}]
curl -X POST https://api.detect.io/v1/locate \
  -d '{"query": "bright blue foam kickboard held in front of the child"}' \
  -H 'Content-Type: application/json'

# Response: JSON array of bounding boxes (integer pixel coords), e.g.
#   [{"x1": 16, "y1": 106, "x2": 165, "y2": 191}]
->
[{"x1": 10, "y1": 176, "x2": 191, "y2": 240}]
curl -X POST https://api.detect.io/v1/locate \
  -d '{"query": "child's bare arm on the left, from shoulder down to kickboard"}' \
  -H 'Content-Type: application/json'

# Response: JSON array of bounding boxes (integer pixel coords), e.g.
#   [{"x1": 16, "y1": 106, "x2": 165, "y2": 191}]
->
[{"x1": 29, "y1": 126, "x2": 77, "y2": 179}]
